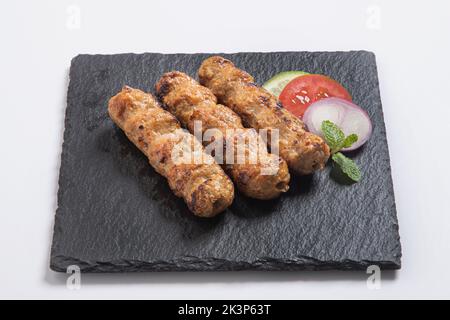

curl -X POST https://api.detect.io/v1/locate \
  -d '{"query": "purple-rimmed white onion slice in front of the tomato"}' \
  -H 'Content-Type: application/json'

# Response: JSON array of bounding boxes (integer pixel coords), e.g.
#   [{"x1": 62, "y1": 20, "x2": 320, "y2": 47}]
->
[{"x1": 303, "y1": 98, "x2": 372, "y2": 151}]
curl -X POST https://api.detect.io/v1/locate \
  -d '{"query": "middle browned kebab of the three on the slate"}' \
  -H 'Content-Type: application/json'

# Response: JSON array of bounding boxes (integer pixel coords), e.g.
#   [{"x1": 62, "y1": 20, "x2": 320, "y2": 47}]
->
[{"x1": 156, "y1": 71, "x2": 290, "y2": 200}]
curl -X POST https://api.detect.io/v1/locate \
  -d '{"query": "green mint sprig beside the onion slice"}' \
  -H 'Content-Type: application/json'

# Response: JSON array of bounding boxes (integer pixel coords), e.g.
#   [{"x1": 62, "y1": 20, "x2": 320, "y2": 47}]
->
[{"x1": 321, "y1": 120, "x2": 361, "y2": 182}]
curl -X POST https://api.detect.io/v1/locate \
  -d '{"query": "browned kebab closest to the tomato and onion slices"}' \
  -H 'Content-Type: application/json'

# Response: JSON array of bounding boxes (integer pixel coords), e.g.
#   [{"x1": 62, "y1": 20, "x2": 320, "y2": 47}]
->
[{"x1": 198, "y1": 56, "x2": 330, "y2": 174}]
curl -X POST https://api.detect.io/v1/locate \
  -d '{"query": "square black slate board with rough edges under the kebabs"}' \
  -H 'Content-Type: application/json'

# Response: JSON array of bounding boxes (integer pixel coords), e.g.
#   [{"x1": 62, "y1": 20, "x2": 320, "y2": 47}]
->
[{"x1": 50, "y1": 51, "x2": 401, "y2": 272}]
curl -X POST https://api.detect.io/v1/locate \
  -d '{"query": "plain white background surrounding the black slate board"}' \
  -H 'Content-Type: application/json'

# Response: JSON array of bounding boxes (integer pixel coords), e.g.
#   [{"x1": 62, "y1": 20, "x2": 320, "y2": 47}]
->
[{"x1": 0, "y1": 0, "x2": 450, "y2": 299}]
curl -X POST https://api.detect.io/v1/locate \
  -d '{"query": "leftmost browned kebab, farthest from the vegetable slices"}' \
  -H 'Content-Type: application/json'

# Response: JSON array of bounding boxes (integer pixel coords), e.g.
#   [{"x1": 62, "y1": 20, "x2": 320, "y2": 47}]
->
[{"x1": 108, "y1": 87, "x2": 234, "y2": 217}]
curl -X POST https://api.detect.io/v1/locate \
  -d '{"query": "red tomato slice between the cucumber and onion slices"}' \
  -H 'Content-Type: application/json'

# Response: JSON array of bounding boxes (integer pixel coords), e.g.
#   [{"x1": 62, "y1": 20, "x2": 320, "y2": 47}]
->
[{"x1": 279, "y1": 74, "x2": 352, "y2": 118}]
